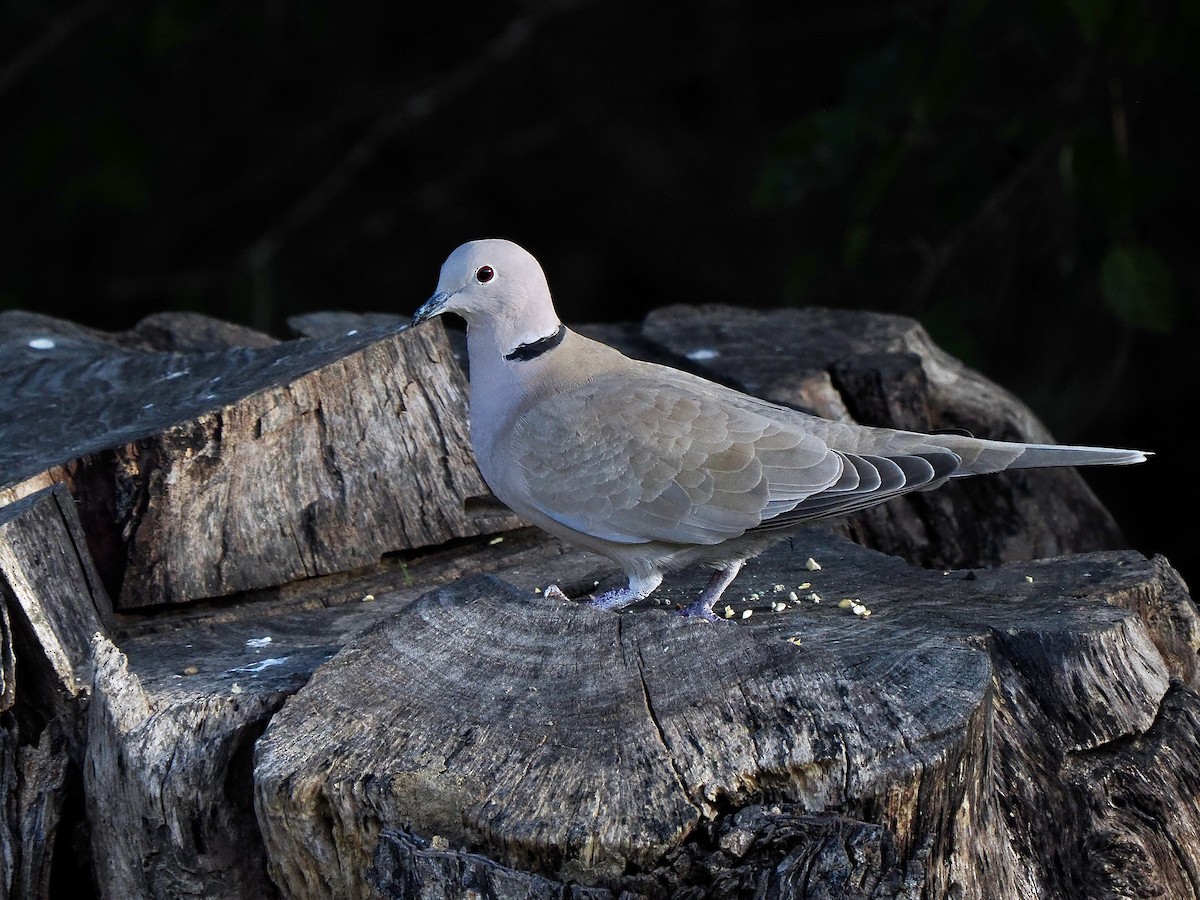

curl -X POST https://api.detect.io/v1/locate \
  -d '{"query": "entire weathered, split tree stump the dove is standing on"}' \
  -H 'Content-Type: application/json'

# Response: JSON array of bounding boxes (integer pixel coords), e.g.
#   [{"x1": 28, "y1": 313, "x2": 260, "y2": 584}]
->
[{"x1": 0, "y1": 307, "x2": 1185, "y2": 900}]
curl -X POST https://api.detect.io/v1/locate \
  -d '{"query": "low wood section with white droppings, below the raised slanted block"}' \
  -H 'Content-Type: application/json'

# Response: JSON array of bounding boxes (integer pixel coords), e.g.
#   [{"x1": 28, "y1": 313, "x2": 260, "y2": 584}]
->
[{"x1": 85, "y1": 529, "x2": 599, "y2": 900}]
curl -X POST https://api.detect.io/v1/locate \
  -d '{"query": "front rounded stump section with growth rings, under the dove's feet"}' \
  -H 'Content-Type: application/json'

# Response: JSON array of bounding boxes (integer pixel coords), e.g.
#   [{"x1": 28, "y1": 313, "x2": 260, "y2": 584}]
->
[{"x1": 248, "y1": 532, "x2": 1200, "y2": 896}]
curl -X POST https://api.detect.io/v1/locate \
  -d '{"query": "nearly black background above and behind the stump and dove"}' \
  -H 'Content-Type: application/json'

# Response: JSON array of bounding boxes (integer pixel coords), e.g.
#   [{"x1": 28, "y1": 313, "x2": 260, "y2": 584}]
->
[{"x1": 0, "y1": 0, "x2": 1200, "y2": 588}]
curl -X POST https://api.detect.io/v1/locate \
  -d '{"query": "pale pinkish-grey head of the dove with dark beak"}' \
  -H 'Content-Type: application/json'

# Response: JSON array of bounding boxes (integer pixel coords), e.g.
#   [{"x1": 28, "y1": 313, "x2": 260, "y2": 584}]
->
[{"x1": 413, "y1": 240, "x2": 562, "y2": 354}]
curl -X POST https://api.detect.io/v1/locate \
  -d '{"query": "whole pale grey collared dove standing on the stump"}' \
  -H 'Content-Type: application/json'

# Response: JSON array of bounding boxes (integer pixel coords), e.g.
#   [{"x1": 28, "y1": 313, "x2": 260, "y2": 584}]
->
[{"x1": 413, "y1": 240, "x2": 1146, "y2": 619}]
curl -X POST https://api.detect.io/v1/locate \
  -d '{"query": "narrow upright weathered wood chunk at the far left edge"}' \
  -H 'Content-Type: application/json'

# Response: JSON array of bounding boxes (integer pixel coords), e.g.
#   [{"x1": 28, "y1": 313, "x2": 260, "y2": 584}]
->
[{"x1": 0, "y1": 485, "x2": 113, "y2": 898}]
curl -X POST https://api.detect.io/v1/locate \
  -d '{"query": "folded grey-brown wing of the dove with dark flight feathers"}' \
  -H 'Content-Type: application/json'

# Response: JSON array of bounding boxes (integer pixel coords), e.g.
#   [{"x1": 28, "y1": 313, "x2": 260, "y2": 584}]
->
[{"x1": 509, "y1": 372, "x2": 958, "y2": 544}]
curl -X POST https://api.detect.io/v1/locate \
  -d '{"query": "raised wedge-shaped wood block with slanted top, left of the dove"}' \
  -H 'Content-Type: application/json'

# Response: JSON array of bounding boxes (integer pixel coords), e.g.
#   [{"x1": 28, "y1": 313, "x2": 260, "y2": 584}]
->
[{"x1": 0, "y1": 313, "x2": 512, "y2": 608}]
